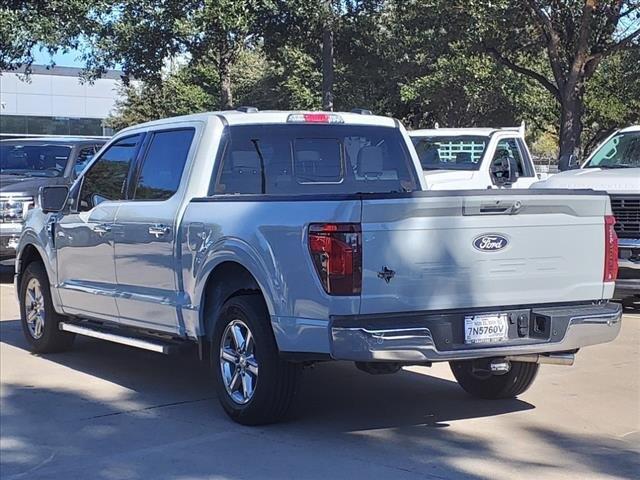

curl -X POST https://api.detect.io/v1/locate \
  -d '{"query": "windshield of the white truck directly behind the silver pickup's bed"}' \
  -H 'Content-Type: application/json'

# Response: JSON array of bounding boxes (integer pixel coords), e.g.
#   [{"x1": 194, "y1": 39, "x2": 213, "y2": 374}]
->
[{"x1": 412, "y1": 135, "x2": 489, "y2": 170}]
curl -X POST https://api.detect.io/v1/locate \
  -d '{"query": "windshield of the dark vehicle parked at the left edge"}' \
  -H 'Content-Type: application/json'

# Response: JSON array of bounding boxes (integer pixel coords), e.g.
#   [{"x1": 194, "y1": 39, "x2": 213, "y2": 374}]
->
[{"x1": 0, "y1": 143, "x2": 71, "y2": 177}]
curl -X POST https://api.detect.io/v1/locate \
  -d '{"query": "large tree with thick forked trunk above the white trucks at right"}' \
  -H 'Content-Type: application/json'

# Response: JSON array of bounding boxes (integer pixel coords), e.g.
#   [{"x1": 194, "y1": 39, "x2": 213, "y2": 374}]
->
[{"x1": 464, "y1": 0, "x2": 640, "y2": 155}]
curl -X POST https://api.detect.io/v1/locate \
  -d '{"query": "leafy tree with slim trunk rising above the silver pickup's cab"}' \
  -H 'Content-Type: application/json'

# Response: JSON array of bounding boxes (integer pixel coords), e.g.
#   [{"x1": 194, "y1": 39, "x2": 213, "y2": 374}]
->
[{"x1": 86, "y1": 0, "x2": 271, "y2": 108}]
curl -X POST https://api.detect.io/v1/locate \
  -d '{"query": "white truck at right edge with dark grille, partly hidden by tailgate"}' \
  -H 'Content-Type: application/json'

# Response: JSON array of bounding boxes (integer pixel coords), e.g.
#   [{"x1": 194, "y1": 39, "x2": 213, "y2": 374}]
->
[{"x1": 534, "y1": 125, "x2": 640, "y2": 302}]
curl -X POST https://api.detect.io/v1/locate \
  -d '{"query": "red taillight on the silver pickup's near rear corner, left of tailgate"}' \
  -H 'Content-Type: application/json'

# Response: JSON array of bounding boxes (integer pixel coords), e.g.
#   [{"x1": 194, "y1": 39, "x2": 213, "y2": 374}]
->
[{"x1": 309, "y1": 223, "x2": 362, "y2": 295}]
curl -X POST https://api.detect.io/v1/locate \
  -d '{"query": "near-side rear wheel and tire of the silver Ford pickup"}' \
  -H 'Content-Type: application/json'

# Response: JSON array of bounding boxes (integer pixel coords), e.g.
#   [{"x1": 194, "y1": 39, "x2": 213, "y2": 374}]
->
[{"x1": 211, "y1": 295, "x2": 301, "y2": 425}]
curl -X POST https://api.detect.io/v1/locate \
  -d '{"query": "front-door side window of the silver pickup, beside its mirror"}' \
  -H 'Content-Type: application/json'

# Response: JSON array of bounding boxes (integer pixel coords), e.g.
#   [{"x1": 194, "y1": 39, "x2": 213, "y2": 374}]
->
[{"x1": 78, "y1": 135, "x2": 140, "y2": 212}]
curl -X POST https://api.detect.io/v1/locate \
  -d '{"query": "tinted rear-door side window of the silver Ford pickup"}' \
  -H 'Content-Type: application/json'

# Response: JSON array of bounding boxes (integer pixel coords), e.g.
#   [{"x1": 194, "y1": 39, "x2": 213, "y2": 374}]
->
[{"x1": 133, "y1": 128, "x2": 195, "y2": 200}]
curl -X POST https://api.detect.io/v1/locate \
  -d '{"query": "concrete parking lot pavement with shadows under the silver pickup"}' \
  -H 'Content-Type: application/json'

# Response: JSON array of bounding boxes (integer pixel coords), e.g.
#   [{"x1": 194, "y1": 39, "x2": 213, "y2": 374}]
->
[{"x1": 0, "y1": 268, "x2": 640, "y2": 480}]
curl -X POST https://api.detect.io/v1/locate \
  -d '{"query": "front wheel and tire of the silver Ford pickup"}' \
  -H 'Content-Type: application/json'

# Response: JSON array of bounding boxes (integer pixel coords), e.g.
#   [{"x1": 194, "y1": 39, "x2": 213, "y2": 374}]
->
[{"x1": 19, "y1": 262, "x2": 75, "y2": 353}]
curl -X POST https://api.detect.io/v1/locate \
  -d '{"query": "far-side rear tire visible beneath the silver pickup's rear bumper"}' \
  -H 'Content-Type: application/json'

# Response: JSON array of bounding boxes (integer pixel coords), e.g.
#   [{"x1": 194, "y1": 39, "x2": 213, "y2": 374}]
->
[{"x1": 449, "y1": 360, "x2": 539, "y2": 399}]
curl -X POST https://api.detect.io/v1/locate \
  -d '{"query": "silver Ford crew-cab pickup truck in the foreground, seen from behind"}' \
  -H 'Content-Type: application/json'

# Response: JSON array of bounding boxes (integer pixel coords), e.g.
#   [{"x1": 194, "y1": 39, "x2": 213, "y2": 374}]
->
[{"x1": 16, "y1": 108, "x2": 621, "y2": 424}]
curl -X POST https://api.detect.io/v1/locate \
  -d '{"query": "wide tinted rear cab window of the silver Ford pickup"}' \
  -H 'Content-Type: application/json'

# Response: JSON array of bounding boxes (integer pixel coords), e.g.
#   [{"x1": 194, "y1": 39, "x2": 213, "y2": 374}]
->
[{"x1": 209, "y1": 124, "x2": 419, "y2": 195}]
